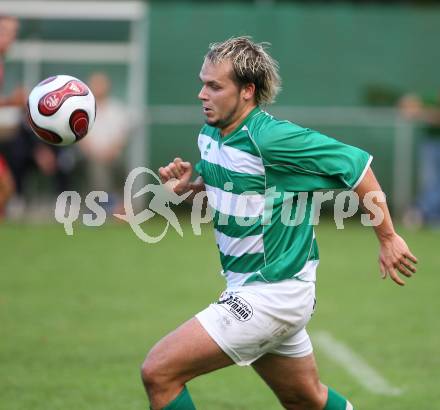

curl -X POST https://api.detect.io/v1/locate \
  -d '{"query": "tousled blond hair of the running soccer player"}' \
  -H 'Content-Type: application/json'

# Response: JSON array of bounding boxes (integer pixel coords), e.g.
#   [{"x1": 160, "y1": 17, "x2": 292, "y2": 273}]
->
[{"x1": 205, "y1": 36, "x2": 281, "y2": 105}]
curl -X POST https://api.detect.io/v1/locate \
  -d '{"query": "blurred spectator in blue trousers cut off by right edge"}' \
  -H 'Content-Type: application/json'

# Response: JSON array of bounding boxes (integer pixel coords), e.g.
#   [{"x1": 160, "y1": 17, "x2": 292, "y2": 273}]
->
[{"x1": 399, "y1": 92, "x2": 440, "y2": 226}]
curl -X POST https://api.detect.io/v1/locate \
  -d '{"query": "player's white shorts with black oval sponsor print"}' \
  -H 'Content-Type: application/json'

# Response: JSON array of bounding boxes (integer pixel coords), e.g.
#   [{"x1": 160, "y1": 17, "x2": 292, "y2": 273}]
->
[{"x1": 196, "y1": 279, "x2": 315, "y2": 366}]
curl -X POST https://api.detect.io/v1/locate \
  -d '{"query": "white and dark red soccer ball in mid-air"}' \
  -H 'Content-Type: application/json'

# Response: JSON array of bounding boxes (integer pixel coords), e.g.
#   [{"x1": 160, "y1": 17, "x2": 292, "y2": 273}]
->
[{"x1": 27, "y1": 75, "x2": 96, "y2": 145}]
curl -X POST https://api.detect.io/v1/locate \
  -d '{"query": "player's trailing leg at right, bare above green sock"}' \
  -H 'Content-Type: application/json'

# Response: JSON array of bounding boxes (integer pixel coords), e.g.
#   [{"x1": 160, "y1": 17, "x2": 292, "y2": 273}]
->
[{"x1": 252, "y1": 353, "x2": 353, "y2": 410}]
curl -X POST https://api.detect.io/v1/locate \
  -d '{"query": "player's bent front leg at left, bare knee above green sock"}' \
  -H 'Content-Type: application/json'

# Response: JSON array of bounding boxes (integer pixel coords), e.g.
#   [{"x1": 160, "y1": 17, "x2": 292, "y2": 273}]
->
[{"x1": 142, "y1": 318, "x2": 234, "y2": 410}]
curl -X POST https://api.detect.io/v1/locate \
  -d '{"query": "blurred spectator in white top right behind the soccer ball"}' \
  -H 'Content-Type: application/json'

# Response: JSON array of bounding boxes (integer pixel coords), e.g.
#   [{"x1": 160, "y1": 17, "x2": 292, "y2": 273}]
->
[{"x1": 79, "y1": 72, "x2": 129, "y2": 212}]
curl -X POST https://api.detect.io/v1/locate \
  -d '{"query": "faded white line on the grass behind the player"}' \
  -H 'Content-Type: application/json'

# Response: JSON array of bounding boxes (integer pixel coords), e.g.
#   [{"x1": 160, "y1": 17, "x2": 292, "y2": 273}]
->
[{"x1": 313, "y1": 332, "x2": 403, "y2": 396}]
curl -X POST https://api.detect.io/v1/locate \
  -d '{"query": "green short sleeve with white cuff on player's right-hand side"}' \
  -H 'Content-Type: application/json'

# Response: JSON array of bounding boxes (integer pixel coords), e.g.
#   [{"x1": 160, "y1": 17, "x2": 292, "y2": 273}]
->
[{"x1": 257, "y1": 121, "x2": 372, "y2": 190}]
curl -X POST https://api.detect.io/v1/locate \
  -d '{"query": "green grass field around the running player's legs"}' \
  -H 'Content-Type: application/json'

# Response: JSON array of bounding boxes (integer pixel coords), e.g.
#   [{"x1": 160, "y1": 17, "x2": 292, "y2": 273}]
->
[{"x1": 0, "y1": 216, "x2": 440, "y2": 410}]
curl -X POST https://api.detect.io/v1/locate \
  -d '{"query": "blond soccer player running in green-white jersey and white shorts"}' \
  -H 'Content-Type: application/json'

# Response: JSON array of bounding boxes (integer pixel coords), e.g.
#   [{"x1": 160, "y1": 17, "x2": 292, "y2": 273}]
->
[{"x1": 142, "y1": 37, "x2": 416, "y2": 410}]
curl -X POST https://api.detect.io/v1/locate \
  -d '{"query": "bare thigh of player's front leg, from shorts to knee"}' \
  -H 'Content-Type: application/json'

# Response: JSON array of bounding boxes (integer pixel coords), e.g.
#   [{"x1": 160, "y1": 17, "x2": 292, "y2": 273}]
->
[{"x1": 146, "y1": 318, "x2": 234, "y2": 384}]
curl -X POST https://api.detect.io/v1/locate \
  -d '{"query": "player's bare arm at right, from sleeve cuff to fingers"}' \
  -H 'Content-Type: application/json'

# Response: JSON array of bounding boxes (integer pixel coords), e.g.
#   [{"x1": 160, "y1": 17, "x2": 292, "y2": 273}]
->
[{"x1": 354, "y1": 168, "x2": 417, "y2": 286}]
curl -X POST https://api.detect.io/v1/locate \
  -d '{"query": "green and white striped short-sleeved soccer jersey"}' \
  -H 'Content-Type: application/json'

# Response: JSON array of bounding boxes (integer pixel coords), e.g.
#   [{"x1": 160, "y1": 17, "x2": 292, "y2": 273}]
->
[{"x1": 196, "y1": 107, "x2": 371, "y2": 287}]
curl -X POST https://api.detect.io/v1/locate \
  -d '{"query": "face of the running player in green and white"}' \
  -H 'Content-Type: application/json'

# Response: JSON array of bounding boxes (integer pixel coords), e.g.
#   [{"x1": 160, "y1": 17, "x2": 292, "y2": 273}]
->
[{"x1": 198, "y1": 60, "x2": 245, "y2": 129}]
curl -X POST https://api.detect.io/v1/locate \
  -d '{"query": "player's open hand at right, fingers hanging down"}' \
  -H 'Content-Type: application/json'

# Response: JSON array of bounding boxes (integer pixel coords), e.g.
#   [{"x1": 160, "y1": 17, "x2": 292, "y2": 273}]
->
[{"x1": 379, "y1": 233, "x2": 417, "y2": 286}]
